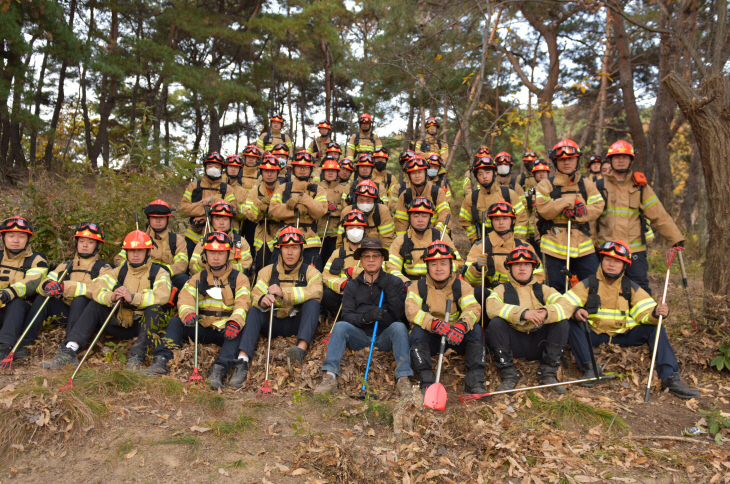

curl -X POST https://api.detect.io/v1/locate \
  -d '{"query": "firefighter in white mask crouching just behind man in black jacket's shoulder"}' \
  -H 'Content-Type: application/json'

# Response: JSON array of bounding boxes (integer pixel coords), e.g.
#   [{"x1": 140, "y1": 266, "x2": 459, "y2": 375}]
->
[{"x1": 322, "y1": 208, "x2": 368, "y2": 318}]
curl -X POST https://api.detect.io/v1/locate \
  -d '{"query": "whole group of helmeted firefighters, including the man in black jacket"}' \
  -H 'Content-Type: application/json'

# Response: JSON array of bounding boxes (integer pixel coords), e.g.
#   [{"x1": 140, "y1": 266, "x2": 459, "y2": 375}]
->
[{"x1": 0, "y1": 114, "x2": 700, "y2": 398}]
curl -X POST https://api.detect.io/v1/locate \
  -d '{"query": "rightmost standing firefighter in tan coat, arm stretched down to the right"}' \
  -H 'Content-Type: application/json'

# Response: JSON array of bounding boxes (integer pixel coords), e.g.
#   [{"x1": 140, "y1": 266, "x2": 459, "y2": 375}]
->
[{"x1": 597, "y1": 141, "x2": 684, "y2": 294}]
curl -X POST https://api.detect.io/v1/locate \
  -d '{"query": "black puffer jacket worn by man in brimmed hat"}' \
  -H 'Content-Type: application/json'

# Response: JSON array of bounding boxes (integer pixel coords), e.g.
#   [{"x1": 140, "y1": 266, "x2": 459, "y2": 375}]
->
[{"x1": 340, "y1": 270, "x2": 406, "y2": 333}]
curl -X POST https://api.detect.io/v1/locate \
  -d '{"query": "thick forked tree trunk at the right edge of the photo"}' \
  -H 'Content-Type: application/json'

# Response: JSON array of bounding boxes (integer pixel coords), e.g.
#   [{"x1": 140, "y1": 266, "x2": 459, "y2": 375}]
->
[{"x1": 662, "y1": 71, "x2": 730, "y2": 298}]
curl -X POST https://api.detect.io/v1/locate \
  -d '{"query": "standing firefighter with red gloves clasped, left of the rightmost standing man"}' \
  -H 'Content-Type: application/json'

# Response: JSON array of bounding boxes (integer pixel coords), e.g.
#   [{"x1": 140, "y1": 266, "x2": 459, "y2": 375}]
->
[{"x1": 535, "y1": 139, "x2": 605, "y2": 291}]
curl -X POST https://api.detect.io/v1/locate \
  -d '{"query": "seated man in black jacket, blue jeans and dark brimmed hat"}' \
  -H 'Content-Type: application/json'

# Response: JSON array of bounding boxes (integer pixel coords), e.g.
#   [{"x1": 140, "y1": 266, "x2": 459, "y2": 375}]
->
[{"x1": 314, "y1": 237, "x2": 413, "y2": 396}]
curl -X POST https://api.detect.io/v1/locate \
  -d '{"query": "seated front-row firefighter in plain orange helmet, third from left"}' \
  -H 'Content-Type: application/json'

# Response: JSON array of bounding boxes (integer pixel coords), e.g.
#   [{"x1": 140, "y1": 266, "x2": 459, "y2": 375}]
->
[{"x1": 61, "y1": 230, "x2": 171, "y2": 371}]
